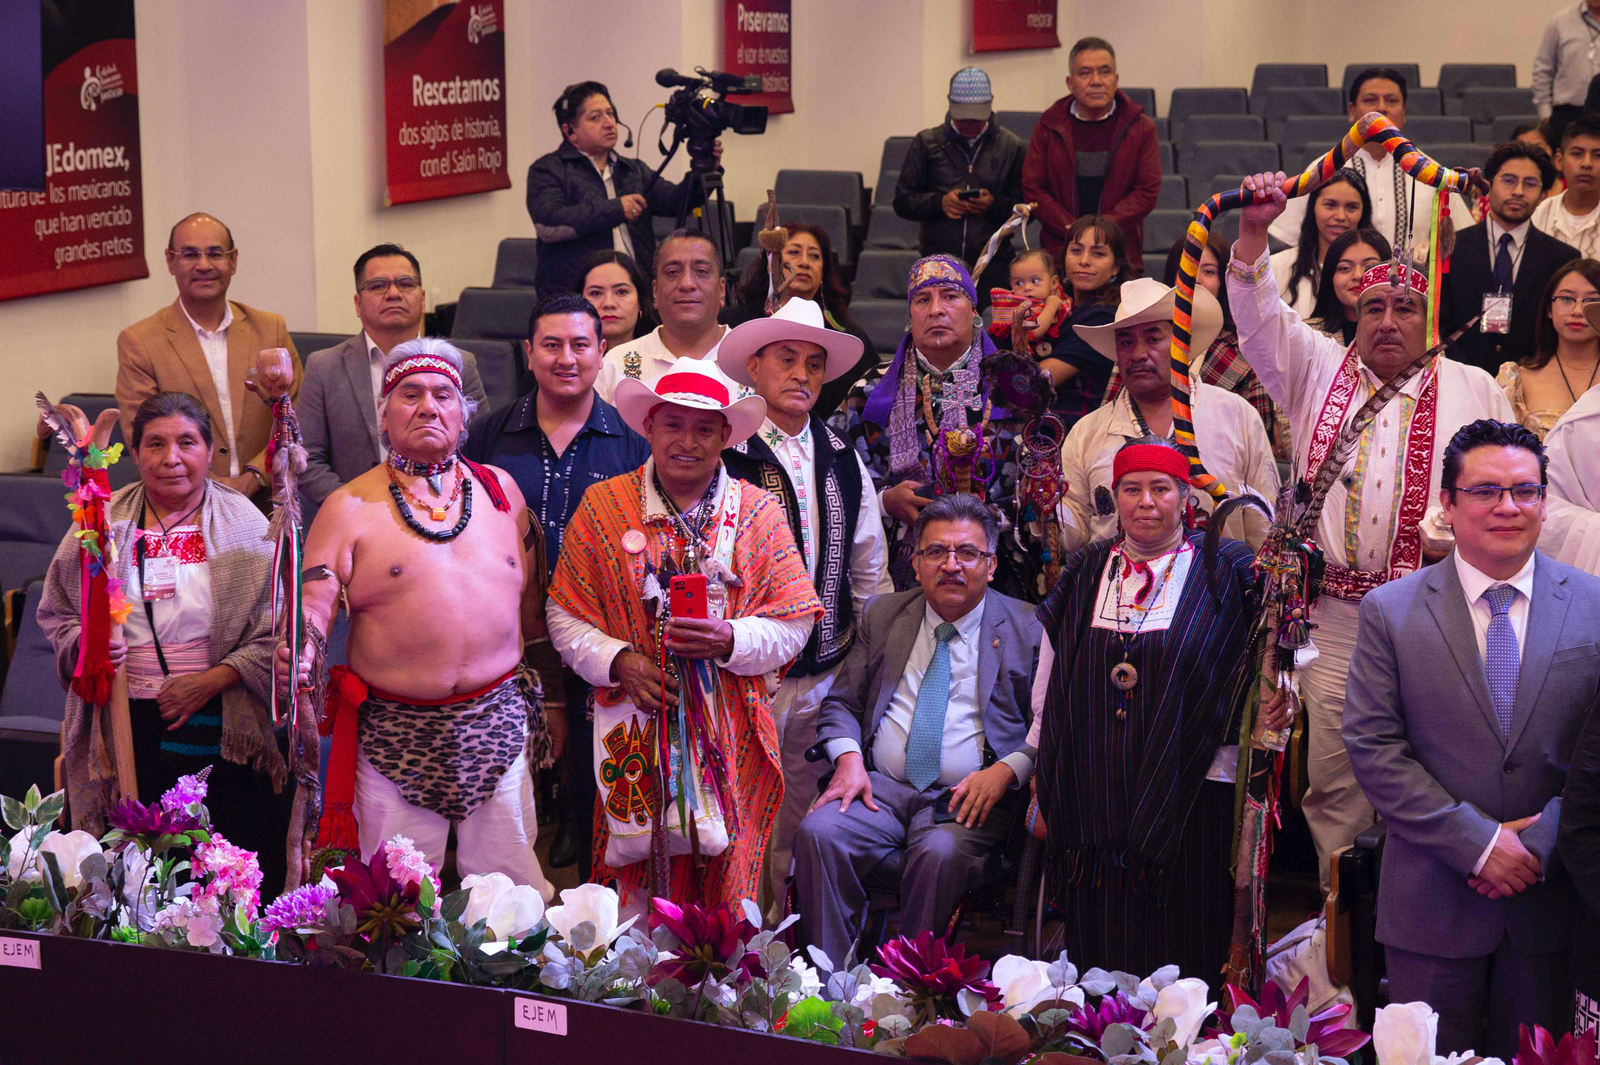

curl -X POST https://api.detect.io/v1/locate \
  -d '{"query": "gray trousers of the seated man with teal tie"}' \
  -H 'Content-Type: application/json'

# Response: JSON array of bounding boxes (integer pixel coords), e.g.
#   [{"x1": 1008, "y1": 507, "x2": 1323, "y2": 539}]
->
[{"x1": 794, "y1": 769, "x2": 1022, "y2": 966}]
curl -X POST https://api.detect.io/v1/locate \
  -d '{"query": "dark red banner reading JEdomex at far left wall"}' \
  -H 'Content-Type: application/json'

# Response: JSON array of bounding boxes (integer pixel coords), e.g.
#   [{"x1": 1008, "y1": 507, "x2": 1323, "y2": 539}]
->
[{"x1": 0, "y1": 0, "x2": 150, "y2": 299}]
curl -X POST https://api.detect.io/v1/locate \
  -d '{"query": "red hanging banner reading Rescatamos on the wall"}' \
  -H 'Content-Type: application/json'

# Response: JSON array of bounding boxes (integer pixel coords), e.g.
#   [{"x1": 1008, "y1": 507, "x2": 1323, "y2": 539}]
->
[{"x1": 384, "y1": 0, "x2": 510, "y2": 206}]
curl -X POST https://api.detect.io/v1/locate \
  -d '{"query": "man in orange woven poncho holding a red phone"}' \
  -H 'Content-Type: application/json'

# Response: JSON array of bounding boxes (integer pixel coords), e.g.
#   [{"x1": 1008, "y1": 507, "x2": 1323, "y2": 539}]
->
[{"x1": 549, "y1": 360, "x2": 822, "y2": 911}]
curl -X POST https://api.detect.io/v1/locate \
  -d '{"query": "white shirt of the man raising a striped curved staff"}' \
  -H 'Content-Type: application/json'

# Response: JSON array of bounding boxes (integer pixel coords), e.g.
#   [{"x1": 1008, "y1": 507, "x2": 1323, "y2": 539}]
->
[{"x1": 1222, "y1": 243, "x2": 1517, "y2": 569}]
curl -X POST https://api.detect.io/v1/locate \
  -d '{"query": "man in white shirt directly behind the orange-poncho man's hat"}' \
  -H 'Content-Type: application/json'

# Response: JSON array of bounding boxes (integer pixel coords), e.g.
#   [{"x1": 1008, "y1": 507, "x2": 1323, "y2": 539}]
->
[{"x1": 595, "y1": 229, "x2": 728, "y2": 403}]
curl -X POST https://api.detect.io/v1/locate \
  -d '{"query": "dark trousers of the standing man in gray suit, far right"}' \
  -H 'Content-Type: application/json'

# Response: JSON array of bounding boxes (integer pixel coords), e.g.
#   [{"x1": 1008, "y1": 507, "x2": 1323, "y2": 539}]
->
[{"x1": 1384, "y1": 935, "x2": 1573, "y2": 1062}]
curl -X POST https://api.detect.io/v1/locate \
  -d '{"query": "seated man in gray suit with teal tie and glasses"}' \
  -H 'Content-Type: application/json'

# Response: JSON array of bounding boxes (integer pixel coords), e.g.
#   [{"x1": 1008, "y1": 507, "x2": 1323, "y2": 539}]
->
[{"x1": 794, "y1": 496, "x2": 1040, "y2": 964}]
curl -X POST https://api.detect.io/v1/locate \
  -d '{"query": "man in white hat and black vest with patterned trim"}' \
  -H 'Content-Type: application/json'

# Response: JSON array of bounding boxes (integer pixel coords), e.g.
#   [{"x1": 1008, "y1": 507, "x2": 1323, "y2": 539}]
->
[{"x1": 717, "y1": 299, "x2": 894, "y2": 900}]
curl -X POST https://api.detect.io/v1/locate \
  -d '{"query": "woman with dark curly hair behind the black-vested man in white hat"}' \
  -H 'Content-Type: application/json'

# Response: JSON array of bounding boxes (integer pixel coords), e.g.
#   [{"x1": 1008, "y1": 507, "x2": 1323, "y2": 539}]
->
[{"x1": 723, "y1": 222, "x2": 878, "y2": 421}]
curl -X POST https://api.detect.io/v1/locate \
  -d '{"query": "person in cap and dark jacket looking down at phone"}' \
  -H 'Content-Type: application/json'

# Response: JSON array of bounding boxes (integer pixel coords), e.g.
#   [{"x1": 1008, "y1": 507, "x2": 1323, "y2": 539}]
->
[{"x1": 894, "y1": 67, "x2": 1027, "y2": 312}]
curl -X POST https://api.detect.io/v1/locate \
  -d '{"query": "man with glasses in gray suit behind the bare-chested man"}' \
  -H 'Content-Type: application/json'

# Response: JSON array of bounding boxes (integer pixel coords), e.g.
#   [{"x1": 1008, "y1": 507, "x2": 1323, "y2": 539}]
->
[{"x1": 294, "y1": 243, "x2": 485, "y2": 529}]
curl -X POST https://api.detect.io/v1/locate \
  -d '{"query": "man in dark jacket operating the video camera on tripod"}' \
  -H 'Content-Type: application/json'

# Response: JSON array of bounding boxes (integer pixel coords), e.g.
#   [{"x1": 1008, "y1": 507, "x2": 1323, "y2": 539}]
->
[{"x1": 528, "y1": 82, "x2": 722, "y2": 294}]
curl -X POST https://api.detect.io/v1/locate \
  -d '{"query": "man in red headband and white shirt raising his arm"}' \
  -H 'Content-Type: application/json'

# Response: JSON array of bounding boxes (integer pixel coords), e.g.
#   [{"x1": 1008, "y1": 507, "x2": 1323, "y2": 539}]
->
[{"x1": 1227, "y1": 171, "x2": 1515, "y2": 891}]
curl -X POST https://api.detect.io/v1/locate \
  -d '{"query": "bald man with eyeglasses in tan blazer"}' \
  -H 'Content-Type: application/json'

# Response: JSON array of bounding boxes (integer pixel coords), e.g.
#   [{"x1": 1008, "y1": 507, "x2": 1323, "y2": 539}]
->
[{"x1": 117, "y1": 213, "x2": 301, "y2": 496}]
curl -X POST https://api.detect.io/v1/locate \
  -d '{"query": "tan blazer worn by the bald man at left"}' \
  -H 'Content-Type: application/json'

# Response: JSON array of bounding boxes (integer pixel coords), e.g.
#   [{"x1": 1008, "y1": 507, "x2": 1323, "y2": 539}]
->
[{"x1": 117, "y1": 301, "x2": 302, "y2": 477}]
